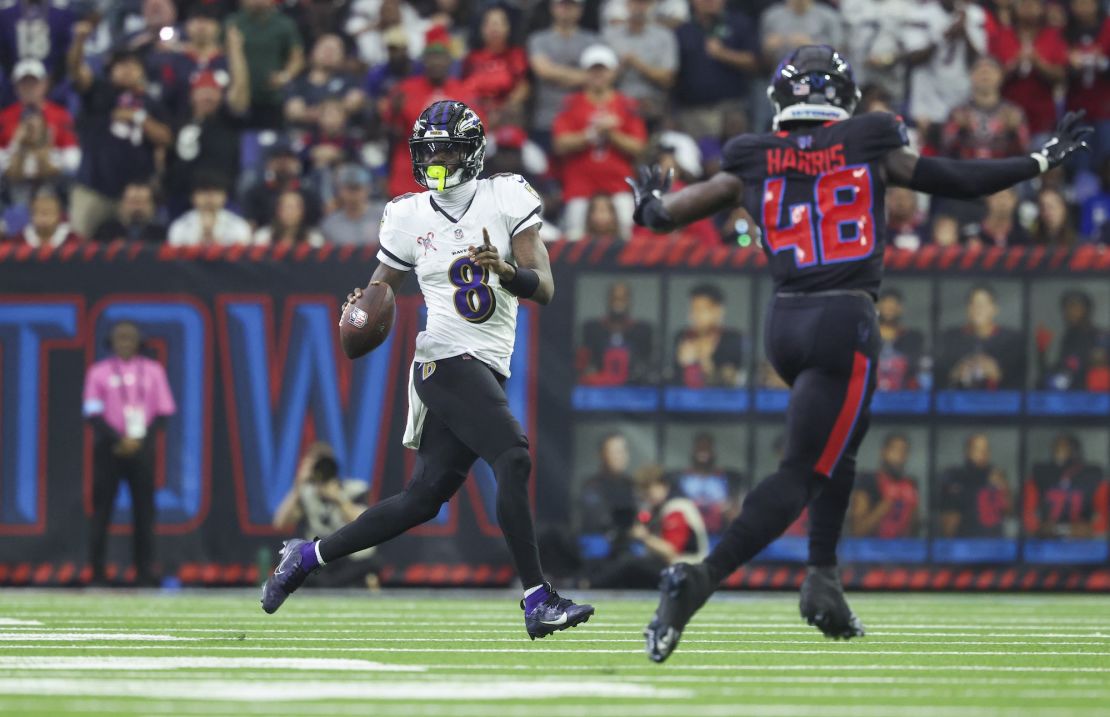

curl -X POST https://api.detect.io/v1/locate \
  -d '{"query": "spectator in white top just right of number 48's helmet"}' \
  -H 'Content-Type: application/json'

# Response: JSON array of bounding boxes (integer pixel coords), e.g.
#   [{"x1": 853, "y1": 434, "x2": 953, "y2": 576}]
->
[{"x1": 839, "y1": 0, "x2": 912, "y2": 108}]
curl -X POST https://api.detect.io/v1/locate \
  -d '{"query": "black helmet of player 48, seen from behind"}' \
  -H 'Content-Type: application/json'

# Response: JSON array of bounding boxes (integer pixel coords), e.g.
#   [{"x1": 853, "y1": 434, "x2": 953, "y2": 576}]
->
[{"x1": 767, "y1": 44, "x2": 859, "y2": 130}]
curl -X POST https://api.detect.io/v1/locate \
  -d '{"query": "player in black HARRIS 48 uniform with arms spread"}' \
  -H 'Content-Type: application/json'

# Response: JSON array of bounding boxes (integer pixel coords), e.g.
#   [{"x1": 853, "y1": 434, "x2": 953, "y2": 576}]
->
[{"x1": 629, "y1": 46, "x2": 1091, "y2": 662}]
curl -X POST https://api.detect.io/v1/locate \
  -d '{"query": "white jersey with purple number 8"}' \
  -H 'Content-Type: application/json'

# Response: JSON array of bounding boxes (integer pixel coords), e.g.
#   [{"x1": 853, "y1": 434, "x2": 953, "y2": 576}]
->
[{"x1": 377, "y1": 174, "x2": 543, "y2": 376}]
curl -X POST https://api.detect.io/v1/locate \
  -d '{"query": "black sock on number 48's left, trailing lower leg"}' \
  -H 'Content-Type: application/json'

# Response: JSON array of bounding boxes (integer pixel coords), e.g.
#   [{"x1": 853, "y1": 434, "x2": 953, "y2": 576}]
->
[{"x1": 705, "y1": 467, "x2": 826, "y2": 584}]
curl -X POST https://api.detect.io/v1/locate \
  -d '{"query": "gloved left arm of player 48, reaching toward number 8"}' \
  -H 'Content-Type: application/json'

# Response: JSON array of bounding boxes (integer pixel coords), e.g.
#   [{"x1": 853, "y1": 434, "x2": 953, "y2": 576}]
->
[{"x1": 625, "y1": 165, "x2": 744, "y2": 233}]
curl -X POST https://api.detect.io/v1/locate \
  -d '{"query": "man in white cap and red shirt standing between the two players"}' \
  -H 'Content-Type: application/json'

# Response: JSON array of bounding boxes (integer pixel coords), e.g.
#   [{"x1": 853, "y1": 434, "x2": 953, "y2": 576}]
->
[{"x1": 552, "y1": 44, "x2": 647, "y2": 241}]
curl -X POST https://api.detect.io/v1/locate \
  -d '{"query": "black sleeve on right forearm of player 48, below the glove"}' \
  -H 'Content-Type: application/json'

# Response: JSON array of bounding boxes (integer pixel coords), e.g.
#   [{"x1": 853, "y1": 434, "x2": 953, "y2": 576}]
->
[{"x1": 909, "y1": 156, "x2": 1040, "y2": 199}]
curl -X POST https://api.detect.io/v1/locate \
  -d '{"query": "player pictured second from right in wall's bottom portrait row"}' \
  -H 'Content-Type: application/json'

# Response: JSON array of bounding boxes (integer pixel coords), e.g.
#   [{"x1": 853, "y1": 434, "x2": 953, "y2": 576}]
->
[{"x1": 937, "y1": 433, "x2": 1013, "y2": 538}]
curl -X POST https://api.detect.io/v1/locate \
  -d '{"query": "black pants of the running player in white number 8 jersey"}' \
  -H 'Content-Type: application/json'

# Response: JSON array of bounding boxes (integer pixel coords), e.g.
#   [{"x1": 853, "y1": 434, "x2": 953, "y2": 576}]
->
[{"x1": 320, "y1": 354, "x2": 544, "y2": 587}]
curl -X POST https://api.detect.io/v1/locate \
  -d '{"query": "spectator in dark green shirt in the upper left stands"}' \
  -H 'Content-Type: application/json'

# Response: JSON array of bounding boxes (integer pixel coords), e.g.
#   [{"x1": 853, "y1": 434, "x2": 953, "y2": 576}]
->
[{"x1": 228, "y1": 0, "x2": 304, "y2": 128}]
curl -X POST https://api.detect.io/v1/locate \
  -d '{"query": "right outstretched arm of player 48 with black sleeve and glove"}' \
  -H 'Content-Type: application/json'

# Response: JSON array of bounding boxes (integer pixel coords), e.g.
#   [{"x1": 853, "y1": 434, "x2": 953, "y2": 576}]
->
[{"x1": 885, "y1": 112, "x2": 1093, "y2": 199}]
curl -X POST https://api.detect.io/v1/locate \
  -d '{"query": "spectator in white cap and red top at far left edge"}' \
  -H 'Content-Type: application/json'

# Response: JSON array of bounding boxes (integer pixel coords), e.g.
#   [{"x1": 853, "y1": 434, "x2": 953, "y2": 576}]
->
[{"x1": 0, "y1": 60, "x2": 81, "y2": 203}]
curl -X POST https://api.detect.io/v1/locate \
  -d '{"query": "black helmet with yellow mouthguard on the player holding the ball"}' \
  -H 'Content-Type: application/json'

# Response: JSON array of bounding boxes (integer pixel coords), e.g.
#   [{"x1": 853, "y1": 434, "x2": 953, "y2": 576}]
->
[{"x1": 408, "y1": 100, "x2": 485, "y2": 192}]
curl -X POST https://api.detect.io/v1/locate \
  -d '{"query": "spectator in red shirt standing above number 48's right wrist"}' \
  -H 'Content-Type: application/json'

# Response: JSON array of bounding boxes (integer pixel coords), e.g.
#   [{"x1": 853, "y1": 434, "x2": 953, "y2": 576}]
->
[{"x1": 990, "y1": 0, "x2": 1068, "y2": 135}]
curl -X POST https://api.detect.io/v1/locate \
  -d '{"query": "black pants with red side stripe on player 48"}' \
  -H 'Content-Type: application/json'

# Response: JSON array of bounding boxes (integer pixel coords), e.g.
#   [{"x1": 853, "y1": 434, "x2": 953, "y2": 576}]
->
[{"x1": 706, "y1": 292, "x2": 880, "y2": 579}]
